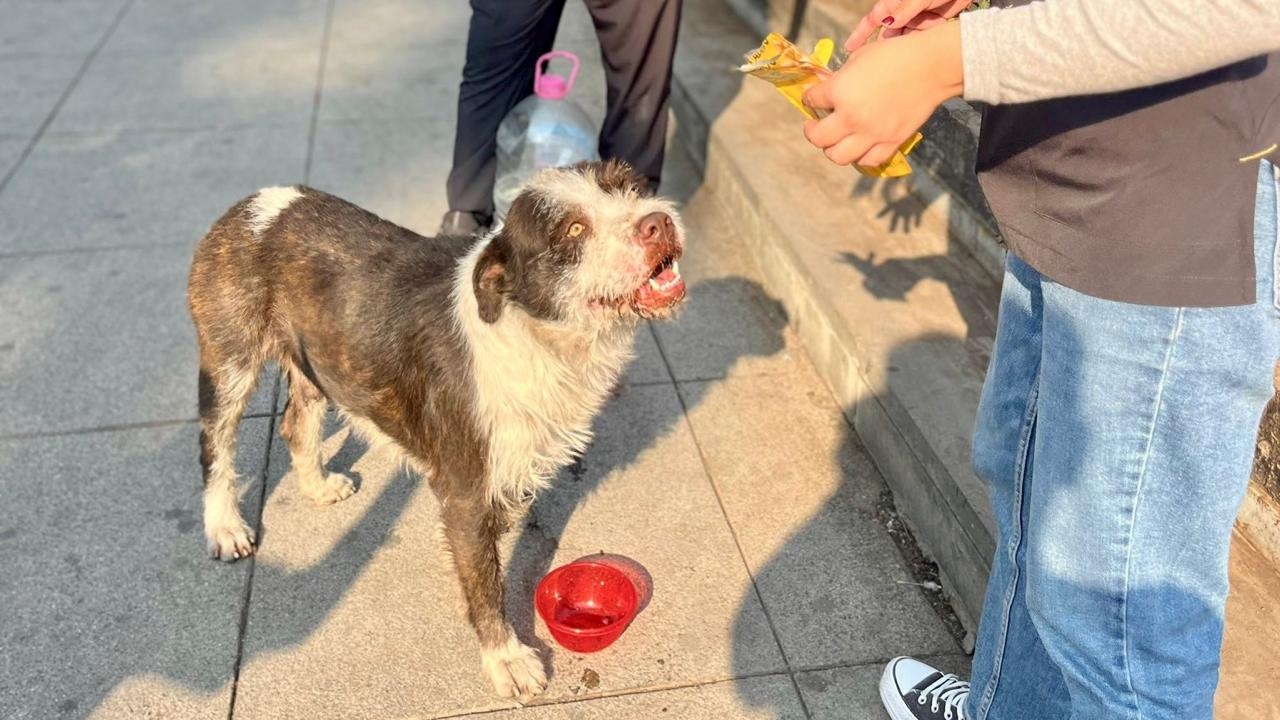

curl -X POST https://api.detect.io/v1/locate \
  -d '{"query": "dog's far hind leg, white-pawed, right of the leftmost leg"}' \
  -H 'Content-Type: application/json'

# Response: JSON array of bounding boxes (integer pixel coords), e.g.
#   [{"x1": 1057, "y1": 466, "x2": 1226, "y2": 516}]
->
[{"x1": 280, "y1": 365, "x2": 356, "y2": 505}]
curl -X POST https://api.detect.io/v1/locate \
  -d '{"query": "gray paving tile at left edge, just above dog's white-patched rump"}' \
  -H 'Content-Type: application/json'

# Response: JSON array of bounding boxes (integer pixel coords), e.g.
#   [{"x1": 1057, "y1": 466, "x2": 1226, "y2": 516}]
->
[{"x1": 0, "y1": 128, "x2": 307, "y2": 254}]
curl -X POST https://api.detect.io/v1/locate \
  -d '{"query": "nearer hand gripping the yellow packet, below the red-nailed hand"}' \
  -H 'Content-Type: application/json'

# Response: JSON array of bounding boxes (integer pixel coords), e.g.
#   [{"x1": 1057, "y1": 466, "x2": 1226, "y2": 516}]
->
[{"x1": 804, "y1": 23, "x2": 964, "y2": 168}]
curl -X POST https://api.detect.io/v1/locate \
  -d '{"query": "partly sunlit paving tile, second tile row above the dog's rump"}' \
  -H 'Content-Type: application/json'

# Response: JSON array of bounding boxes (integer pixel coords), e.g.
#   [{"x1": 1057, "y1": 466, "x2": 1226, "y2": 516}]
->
[{"x1": 50, "y1": 38, "x2": 320, "y2": 133}]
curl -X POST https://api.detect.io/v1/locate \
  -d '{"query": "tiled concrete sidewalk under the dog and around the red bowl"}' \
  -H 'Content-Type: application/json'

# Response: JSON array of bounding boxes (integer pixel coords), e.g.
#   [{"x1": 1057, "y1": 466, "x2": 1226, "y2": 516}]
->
[{"x1": 0, "y1": 0, "x2": 968, "y2": 719}]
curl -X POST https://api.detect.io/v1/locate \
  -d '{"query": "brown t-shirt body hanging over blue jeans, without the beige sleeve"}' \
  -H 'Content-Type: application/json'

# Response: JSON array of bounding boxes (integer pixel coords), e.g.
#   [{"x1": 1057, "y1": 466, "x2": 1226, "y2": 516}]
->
[{"x1": 978, "y1": 0, "x2": 1280, "y2": 306}]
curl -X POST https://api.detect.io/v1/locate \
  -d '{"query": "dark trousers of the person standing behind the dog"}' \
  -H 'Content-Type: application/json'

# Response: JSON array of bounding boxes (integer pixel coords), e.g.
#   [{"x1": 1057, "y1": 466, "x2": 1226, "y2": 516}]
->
[{"x1": 448, "y1": 0, "x2": 681, "y2": 214}]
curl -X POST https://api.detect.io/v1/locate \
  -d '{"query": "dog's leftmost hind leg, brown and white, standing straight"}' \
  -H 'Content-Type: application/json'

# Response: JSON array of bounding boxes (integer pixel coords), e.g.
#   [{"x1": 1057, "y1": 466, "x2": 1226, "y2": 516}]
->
[{"x1": 200, "y1": 357, "x2": 262, "y2": 562}]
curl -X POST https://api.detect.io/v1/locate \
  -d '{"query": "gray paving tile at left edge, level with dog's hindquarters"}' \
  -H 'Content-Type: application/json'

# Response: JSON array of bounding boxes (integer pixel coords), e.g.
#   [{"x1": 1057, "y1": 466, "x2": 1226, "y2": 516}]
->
[{"x1": 0, "y1": 247, "x2": 274, "y2": 436}]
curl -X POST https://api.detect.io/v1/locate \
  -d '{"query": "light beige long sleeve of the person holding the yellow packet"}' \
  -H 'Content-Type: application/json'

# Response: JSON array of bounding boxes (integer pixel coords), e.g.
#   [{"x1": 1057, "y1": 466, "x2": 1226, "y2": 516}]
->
[{"x1": 960, "y1": 0, "x2": 1280, "y2": 105}]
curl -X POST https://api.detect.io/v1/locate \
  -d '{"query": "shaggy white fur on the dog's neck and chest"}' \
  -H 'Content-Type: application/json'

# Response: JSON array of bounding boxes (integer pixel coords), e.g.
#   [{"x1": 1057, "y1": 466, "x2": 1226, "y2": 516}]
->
[{"x1": 454, "y1": 238, "x2": 635, "y2": 506}]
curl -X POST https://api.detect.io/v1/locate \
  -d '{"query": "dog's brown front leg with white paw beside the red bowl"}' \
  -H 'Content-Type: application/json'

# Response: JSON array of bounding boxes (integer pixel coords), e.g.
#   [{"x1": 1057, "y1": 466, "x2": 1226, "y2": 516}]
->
[{"x1": 442, "y1": 488, "x2": 547, "y2": 702}]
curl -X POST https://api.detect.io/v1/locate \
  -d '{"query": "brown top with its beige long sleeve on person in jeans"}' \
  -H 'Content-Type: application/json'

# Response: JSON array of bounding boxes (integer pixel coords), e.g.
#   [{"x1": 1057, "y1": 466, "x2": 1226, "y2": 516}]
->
[{"x1": 960, "y1": 0, "x2": 1280, "y2": 306}]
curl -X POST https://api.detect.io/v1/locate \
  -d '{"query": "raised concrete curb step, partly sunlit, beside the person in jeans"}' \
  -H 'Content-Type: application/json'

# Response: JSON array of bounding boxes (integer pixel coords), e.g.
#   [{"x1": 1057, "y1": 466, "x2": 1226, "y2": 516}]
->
[{"x1": 672, "y1": 1, "x2": 1000, "y2": 630}]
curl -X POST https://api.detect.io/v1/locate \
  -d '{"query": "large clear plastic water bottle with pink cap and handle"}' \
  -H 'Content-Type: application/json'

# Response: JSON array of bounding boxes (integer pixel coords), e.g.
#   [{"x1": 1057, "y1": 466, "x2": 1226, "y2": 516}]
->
[{"x1": 493, "y1": 50, "x2": 599, "y2": 220}]
